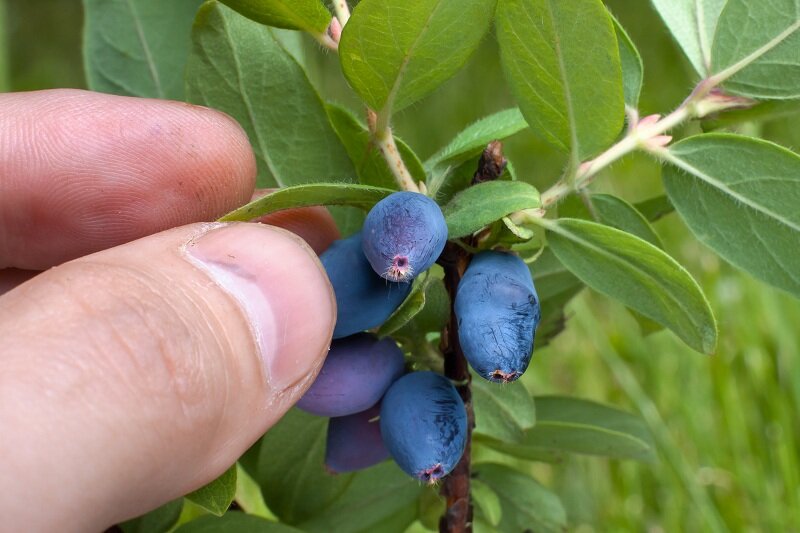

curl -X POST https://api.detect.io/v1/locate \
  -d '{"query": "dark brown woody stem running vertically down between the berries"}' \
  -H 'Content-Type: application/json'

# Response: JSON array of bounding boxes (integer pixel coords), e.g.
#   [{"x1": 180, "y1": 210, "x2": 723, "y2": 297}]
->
[{"x1": 439, "y1": 242, "x2": 475, "y2": 533}]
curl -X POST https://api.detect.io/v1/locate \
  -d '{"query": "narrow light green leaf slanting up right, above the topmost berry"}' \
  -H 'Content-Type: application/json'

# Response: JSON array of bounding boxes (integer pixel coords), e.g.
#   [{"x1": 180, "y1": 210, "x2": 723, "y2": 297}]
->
[{"x1": 425, "y1": 107, "x2": 528, "y2": 172}]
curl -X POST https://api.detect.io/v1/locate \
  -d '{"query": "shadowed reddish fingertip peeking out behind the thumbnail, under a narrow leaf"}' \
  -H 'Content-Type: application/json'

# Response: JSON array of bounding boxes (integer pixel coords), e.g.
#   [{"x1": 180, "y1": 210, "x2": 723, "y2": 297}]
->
[{"x1": 251, "y1": 189, "x2": 341, "y2": 255}]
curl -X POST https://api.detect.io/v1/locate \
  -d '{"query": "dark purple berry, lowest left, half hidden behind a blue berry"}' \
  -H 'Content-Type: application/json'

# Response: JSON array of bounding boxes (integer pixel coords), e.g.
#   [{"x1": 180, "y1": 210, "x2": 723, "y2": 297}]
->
[{"x1": 325, "y1": 405, "x2": 389, "y2": 473}]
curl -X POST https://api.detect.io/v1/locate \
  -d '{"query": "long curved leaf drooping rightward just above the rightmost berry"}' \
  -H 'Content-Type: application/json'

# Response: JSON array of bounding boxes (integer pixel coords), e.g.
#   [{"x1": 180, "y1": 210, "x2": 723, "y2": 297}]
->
[{"x1": 542, "y1": 218, "x2": 717, "y2": 353}]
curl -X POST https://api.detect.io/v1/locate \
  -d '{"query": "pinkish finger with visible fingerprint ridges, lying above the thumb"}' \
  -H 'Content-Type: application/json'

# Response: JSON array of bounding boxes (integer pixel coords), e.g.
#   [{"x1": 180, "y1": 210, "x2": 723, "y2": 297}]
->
[{"x1": 0, "y1": 90, "x2": 256, "y2": 270}]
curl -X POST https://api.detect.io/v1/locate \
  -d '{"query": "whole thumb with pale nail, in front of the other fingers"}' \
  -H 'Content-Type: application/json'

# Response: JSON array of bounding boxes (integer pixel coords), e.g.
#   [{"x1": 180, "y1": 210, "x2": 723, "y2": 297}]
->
[{"x1": 0, "y1": 220, "x2": 335, "y2": 531}]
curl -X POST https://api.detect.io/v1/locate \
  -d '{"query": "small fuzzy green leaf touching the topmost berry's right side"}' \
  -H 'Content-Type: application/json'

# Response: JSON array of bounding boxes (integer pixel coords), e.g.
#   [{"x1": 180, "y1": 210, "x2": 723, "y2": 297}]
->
[{"x1": 442, "y1": 181, "x2": 542, "y2": 239}]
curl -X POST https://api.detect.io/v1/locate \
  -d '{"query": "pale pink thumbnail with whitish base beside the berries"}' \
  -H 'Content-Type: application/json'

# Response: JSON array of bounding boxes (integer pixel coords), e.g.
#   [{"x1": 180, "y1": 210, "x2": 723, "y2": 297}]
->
[{"x1": 186, "y1": 223, "x2": 335, "y2": 390}]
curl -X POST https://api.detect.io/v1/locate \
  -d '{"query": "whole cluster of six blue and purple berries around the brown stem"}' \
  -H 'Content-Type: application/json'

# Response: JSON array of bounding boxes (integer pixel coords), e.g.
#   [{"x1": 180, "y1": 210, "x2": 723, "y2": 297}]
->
[{"x1": 297, "y1": 192, "x2": 540, "y2": 482}]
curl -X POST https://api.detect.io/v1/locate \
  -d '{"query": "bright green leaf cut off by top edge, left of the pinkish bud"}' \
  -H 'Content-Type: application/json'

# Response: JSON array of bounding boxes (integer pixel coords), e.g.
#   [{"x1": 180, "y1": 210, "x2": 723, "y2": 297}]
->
[{"x1": 220, "y1": 0, "x2": 331, "y2": 35}]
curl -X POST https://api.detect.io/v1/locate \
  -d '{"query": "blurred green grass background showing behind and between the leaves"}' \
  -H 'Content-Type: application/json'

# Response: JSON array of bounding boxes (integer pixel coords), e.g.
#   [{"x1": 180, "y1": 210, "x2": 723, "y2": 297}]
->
[{"x1": 7, "y1": 0, "x2": 800, "y2": 532}]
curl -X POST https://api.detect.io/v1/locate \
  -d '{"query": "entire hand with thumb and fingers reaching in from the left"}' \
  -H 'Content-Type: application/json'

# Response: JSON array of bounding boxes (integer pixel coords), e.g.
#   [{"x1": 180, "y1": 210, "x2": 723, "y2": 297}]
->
[{"x1": 0, "y1": 90, "x2": 338, "y2": 532}]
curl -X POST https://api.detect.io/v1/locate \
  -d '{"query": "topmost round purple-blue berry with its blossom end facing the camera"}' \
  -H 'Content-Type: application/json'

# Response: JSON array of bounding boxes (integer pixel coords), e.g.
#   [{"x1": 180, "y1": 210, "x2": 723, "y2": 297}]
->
[{"x1": 362, "y1": 192, "x2": 447, "y2": 282}]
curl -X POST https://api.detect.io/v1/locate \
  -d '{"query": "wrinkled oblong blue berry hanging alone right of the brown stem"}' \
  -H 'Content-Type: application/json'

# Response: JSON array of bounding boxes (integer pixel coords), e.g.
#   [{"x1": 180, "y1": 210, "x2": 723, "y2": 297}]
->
[{"x1": 455, "y1": 251, "x2": 541, "y2": 383}]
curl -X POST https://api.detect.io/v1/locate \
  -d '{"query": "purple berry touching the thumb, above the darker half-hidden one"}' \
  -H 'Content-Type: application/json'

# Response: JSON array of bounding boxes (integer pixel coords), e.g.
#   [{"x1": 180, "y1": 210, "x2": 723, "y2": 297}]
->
[{"x1": 297, "y1": 333, "x2": 404, "y2": 416}]
